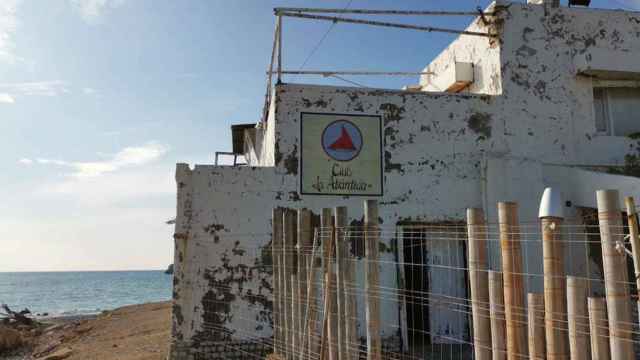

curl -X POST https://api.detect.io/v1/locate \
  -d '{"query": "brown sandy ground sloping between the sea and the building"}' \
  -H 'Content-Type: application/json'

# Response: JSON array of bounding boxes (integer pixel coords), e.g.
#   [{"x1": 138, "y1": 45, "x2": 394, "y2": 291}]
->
[{"x1": 0, "y1": 302, "x2": 171, "y2": 360}]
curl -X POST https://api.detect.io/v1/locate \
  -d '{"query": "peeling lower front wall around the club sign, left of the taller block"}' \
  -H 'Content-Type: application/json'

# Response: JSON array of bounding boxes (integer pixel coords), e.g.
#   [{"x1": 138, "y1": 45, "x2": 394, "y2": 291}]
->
[{"x1": 169, "y1": 85, "x2": 494, "y2": 358}]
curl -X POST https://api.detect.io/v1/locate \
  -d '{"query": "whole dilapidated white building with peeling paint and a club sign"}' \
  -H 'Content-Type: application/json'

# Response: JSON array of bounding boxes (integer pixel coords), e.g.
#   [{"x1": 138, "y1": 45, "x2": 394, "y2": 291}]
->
[{"x1": 171, "y1": 0, "x2": 640, "y2": 360}]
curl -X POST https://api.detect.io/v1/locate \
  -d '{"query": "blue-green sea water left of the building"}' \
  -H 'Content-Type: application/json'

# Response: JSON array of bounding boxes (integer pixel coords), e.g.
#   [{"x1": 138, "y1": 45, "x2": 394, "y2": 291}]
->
[{"x1": 0, "y1": 271, "x2": 173, "y2": 316}]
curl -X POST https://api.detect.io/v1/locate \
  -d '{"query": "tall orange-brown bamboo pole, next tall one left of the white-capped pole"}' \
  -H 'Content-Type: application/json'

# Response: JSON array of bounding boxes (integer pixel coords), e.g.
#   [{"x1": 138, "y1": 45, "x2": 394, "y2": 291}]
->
[{"x1": 498, "y1": 202, "x2": 527, "y2": 360}]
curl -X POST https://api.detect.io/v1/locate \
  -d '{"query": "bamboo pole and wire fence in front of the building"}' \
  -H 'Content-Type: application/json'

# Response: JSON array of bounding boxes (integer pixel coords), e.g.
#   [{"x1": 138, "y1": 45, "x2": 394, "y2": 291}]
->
[{"x1": 191, "y1": 193, "x2": 640, "y2": 360}]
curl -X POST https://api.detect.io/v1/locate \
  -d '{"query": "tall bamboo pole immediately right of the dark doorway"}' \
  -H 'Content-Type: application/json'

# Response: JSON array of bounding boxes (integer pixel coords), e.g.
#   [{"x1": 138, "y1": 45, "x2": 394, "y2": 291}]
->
[{"x1": 467, "y1": 209, "x2": 491, "y2": 360}]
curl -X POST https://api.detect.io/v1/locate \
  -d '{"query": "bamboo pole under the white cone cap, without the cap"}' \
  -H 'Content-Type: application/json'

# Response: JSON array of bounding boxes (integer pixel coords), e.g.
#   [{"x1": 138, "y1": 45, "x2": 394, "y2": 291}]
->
[{"x1": 541, "y1": 216, "x2": 569, "y2": 360}]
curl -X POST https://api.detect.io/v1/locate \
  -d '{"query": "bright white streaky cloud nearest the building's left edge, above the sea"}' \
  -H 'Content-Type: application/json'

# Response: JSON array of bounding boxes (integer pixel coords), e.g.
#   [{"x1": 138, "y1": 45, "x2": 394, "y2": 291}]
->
[{"x1": 36, "y1": 142, "x2": 169, "y2": 178}]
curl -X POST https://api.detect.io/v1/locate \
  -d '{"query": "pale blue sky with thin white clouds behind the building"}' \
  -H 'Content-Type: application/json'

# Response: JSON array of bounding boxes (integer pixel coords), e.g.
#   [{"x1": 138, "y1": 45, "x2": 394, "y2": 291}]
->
[{"x1": 0, "y1": 0, "x2": 640, "y2": 271}]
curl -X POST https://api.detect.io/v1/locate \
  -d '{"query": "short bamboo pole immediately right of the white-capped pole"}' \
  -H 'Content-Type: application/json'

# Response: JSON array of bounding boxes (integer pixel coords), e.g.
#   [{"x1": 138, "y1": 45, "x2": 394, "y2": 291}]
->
[{"x1": 567, "y1": 276, "x2": 590, "y2": 360}]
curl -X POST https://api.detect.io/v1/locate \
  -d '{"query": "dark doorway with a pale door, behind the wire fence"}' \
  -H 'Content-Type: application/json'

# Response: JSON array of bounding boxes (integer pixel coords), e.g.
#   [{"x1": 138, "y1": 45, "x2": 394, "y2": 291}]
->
[{"x1": 398, "y1": 221, "x2": 471, "y2": 359}]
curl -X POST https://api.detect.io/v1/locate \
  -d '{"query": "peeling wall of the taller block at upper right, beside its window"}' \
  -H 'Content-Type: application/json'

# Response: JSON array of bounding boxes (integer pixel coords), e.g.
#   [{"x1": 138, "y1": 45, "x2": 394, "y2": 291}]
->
[{"x1": 495, "y1": 4, "x2": 640, "y2": 164}]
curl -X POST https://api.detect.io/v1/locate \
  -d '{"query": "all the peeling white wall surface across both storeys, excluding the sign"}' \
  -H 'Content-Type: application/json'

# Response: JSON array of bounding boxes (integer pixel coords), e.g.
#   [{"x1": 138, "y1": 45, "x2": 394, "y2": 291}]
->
[{"x1": 173, "y1": 4, "x2": 640, "y2": 357}]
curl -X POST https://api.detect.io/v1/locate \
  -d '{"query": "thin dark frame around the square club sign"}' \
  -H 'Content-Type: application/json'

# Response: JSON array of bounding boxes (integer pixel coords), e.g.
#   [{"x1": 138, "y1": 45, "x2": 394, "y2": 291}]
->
[{"x1": 298, "y1": 111, "x2": 384, "y2": 197}]
